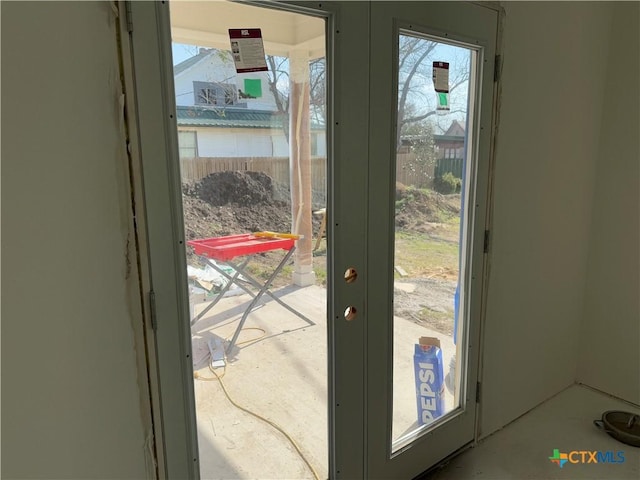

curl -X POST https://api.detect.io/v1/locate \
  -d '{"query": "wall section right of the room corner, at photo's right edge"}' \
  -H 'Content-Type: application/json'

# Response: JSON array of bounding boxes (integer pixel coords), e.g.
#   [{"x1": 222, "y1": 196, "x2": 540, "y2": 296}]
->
[{"x1": 578, "y1": 2, "x2": 640, "y2": 404}]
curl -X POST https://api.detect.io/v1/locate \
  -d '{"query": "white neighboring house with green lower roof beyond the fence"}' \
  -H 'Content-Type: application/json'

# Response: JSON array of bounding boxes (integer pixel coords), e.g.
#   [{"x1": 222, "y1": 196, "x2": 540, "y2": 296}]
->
[{"x1": 174, "y1": 48, "x2": 326, "y2": 158}]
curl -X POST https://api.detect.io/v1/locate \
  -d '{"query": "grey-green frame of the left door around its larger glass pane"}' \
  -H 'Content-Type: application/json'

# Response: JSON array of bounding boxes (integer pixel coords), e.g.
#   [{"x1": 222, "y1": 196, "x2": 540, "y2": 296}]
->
[{"x1": 121, "y1": 1, "x2": 500, "y2": 479}]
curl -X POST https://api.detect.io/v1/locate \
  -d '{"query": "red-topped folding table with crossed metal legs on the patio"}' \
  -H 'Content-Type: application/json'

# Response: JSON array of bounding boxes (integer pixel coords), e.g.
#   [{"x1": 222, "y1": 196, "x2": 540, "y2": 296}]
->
[{"x1": 187, "y1": 232, "x2": 315, "y2": 353}]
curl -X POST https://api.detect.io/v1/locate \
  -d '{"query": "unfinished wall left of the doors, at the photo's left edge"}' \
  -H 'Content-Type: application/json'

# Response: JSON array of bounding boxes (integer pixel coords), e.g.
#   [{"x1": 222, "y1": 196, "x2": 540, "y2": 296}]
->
[{"x1": 1, "y1": 2, "x2": 153, "y2": 479}]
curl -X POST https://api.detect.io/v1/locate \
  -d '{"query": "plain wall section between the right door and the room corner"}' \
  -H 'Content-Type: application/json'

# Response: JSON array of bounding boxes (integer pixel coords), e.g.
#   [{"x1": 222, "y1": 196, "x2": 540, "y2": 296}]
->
[{"x1": 481, "y1": 2, "x2": 610, "y2": 436}]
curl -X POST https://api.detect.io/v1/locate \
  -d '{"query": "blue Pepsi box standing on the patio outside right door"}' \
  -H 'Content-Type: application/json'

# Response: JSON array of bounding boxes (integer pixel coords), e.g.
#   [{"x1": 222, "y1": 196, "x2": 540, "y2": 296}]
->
[{"x1": 413, "y1": 337, "x2": 444, "y2": 425}]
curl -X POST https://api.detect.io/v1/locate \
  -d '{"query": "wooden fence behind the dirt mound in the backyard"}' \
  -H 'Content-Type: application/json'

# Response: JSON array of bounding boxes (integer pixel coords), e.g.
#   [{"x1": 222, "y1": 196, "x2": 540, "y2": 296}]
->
[{"x1": 180, "y1": 153, "x2": 434, "y2": 202}]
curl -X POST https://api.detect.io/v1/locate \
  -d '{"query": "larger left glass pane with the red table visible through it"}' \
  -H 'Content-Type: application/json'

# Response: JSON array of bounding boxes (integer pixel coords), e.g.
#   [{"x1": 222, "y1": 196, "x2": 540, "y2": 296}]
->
[{"x1": 171, "y1": 2, "x2": 329, "y2": 479}]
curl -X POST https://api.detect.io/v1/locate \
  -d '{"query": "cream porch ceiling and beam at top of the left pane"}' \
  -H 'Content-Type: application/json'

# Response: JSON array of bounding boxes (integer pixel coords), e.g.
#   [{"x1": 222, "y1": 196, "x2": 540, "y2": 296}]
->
[{"x1": 170, "y1": 0, "x2": 325, "y2": 58}]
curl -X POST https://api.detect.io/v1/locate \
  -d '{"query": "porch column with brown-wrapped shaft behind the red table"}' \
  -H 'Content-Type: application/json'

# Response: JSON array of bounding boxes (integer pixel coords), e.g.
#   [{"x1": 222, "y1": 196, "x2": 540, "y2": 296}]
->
[{"x1": 289, "y1": 50, "x2": 316, "y2": 287}]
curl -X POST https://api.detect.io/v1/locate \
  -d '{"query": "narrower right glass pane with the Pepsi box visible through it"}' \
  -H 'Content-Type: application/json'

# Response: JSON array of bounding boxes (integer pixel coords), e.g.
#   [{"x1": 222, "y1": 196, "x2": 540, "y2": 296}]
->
[{"x1": 392, "y1": 30, "x2": 476, "y2": 451}]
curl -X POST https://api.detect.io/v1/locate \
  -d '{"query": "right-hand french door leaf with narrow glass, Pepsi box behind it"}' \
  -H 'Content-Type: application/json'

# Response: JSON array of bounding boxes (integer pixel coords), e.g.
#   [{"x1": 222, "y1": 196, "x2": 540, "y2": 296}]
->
[{"x1": 365, "y1": 2, "x2": 497, "y2": 478}]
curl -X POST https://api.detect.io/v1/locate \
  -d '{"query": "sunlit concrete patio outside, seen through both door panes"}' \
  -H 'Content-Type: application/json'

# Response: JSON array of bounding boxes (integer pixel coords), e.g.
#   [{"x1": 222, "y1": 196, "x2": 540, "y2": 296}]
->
[{"x1": 192, "y1": 285, "x2": 455, "y2": 479}]
